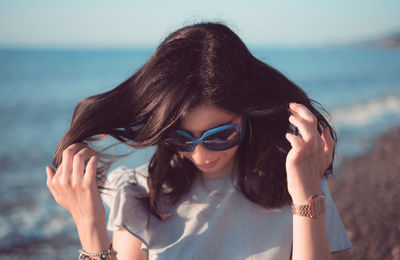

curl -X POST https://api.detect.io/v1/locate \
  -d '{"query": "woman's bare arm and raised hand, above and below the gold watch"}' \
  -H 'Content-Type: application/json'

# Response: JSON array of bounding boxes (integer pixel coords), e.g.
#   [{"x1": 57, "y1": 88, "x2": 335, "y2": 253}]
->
[{"x1": 286, "y1": 103, "x2": 334, "y2": 259}]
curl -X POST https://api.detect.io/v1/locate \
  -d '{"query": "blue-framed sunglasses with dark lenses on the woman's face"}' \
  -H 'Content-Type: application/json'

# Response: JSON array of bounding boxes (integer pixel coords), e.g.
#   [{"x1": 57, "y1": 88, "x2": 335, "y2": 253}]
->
[{"x1": 162, "y1": 119, "x2": 246, "y2": 152}]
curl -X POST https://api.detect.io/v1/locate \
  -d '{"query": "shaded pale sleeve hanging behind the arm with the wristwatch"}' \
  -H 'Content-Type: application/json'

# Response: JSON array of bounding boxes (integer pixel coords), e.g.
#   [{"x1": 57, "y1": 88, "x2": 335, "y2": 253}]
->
[{"x1": 321, "y1": 180, "x2": 352, "y2": 252}]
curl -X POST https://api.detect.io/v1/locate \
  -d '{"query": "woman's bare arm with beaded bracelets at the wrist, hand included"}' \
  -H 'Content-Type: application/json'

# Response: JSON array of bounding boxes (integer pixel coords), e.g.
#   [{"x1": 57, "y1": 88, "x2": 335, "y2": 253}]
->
[{"x1": 46, "y1": 143, "x2": 147, "y2": 260}]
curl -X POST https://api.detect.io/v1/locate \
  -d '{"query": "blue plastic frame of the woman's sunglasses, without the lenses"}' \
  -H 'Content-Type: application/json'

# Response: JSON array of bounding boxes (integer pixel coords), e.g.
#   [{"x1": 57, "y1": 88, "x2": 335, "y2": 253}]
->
[{"x1": 164, "y1": 118, "x2": 246, "y2": 152}]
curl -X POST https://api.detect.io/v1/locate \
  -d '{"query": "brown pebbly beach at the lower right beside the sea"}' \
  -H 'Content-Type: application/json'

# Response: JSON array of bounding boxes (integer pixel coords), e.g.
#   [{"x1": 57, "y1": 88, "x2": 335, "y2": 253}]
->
[{"x1": 328, "y1": 126, "x2": 400, "y2": 260}]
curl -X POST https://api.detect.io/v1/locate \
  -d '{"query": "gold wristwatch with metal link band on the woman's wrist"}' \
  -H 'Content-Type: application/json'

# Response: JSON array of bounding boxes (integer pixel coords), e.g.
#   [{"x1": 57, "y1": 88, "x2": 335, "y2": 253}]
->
[{"x1": 292, "y1": 194, "x2": 326, "y2": 218}]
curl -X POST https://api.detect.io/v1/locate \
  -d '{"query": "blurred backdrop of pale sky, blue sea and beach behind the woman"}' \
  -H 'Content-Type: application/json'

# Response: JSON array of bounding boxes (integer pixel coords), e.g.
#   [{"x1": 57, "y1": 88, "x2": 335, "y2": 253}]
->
[{"x1": 0, "y1": 0, "x2": 400, "y2": 259}]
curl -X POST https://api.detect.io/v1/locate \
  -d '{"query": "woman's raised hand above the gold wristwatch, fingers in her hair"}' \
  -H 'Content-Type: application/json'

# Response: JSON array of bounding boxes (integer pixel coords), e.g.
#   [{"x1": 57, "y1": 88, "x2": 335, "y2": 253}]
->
[{"x1": 286, "y1": 103, "x2": 334, "y2": 202}]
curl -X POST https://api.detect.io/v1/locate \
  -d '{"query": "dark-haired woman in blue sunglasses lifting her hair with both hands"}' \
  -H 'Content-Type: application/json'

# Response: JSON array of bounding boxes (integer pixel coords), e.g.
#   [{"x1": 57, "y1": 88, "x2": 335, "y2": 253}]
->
[{"x1": 46, "y1": 23, "x2": 351, "y2": 259}]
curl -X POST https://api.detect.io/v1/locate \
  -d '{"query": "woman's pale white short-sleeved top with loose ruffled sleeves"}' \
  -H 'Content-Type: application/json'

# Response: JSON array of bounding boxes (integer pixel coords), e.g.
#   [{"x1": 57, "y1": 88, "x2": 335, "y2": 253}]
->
[{"x1": 102, "y1": 164, "x2": 351, "y2": 260}]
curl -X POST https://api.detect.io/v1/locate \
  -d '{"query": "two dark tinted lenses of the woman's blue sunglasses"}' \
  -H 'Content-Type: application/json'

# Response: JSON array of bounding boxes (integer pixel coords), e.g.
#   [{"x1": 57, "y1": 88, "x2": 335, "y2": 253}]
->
[{"x1": 163, "y1": 126, "x2": 241, "y2": 152}]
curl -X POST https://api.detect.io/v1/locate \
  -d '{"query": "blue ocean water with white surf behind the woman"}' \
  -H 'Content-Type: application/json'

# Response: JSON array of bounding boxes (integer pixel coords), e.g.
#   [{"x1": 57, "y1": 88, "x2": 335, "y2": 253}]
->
[{"x1": 0, "y1": 47, "x2": 400, "y2": 259}]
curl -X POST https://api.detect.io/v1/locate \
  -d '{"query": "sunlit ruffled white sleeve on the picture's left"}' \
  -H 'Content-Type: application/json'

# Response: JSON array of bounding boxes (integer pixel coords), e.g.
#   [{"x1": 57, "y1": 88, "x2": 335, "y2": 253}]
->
[{"x1": 101, "y1": 166, "x2": 149, "y2": 250}]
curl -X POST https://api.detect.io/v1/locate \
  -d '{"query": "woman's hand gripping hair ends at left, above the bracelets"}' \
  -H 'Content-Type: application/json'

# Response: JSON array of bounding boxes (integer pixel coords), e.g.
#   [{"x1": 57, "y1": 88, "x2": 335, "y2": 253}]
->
[{"x1": 46, "y1": 143, "x2": 106, "y2": 228}]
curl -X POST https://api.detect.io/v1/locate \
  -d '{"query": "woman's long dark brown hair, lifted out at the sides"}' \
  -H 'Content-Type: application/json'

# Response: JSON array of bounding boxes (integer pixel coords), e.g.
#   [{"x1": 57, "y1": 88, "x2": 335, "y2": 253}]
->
[{"x1": 53, "y1": 23, "x2": 336, "y2": 219}]
